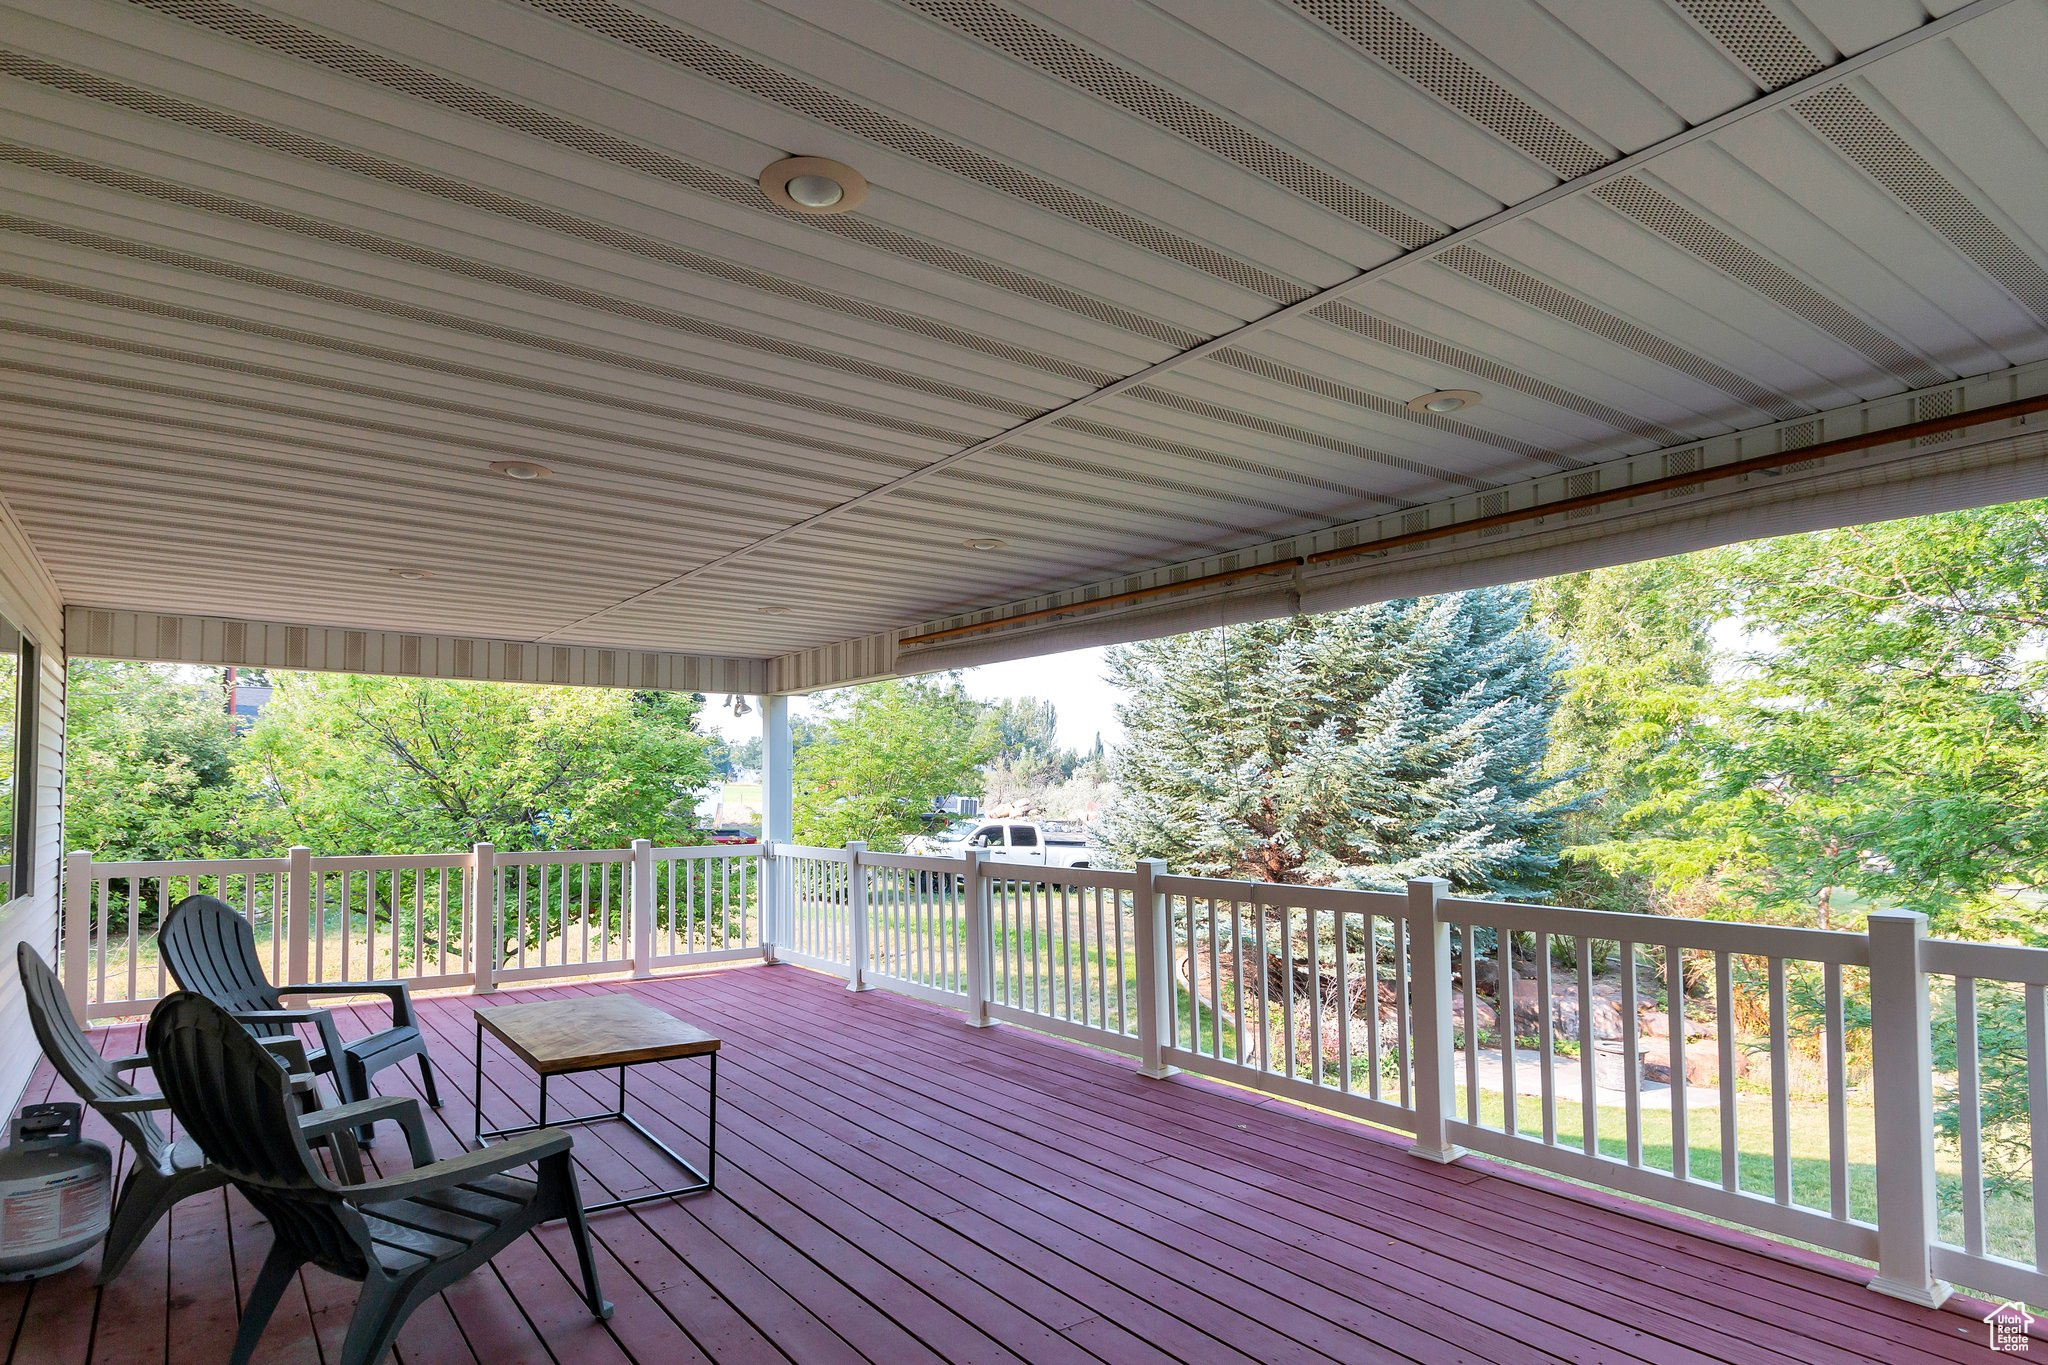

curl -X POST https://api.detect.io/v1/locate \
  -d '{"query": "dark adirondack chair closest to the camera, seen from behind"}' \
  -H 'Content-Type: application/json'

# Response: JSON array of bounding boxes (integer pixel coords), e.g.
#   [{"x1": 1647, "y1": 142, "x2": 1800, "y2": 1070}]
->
[{"x1": 147, "y1": 990, "x2": 612, "y2": 1365}]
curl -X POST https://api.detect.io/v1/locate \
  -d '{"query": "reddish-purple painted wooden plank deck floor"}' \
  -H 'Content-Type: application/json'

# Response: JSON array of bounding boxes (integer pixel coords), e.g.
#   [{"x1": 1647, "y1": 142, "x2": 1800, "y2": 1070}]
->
[{"x1": 0, "y1": 966, "x2": 2007, "y2": 1365}]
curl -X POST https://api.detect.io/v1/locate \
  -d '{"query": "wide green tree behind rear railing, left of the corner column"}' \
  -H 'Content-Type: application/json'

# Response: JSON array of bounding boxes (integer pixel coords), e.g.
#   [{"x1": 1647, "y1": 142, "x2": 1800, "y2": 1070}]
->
[{"x1": 236, "y1": 673, "x2": 711, "y2": 853}]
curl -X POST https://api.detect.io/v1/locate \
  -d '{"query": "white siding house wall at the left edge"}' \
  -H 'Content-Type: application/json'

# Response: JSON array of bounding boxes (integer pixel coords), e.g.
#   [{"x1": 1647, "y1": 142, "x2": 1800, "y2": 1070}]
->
[{"x1": 0, "y1": 505, "x2": 63, "y2": 1115}]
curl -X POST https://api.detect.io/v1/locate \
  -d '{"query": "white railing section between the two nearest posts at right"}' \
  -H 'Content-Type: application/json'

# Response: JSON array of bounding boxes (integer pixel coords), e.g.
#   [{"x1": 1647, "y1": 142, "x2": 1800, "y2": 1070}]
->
[{"x1": 1438, "y1": 898, "x2": 1878, "y2": 1261}]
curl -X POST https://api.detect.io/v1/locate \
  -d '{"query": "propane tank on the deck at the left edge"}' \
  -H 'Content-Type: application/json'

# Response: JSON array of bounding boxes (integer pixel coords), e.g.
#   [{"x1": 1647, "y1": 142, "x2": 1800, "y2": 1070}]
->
[{"x1": 0, "y1": 1103, "x2": 115, "y2": 1279}]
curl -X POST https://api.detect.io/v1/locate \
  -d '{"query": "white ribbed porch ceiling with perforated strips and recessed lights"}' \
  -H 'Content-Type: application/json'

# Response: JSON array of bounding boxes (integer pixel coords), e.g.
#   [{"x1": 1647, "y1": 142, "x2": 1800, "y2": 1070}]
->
[{"x1": 0, "y1": 0, "x2": 2048, "y2": 681}]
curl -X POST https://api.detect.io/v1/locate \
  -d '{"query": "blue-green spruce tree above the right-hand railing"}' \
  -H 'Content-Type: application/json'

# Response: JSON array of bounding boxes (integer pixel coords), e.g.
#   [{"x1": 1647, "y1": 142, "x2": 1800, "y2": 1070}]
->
[{"x1": 1104, "y1": 587, "x2": 1563, "y2": 892}]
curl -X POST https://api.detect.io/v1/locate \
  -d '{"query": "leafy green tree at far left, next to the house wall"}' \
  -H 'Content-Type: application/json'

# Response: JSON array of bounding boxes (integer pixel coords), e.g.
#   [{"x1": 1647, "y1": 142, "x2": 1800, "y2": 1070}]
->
[{"x1": 63, "y1": 659, "x2": 233, "y2": 860}]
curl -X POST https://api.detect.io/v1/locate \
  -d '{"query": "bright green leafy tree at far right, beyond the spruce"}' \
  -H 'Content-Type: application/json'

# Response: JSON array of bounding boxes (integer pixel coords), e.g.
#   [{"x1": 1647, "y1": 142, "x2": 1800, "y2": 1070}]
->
[{"x1": 1597, "y1": 501, "x2": 2048, "y2": 941}]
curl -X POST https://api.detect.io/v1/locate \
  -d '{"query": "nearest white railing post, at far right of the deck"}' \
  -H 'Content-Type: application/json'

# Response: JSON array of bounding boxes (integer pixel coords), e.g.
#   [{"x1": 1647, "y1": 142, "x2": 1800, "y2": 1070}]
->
[{"x1": 1868, "y1": 911, "x2": 1950, "y2": 1308}]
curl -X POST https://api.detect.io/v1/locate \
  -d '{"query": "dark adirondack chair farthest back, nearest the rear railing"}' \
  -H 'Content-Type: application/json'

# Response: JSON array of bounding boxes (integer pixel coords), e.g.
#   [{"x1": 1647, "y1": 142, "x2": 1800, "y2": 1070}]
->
[{"x1": 156, "y1": 896, "x2": 440, "y2": 1142}]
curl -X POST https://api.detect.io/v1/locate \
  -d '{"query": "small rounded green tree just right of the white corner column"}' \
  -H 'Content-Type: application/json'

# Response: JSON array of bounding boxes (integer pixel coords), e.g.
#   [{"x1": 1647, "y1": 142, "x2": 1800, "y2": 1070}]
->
[{"x1": 795, "y1": 675, "x2": 999, "y2": 849}]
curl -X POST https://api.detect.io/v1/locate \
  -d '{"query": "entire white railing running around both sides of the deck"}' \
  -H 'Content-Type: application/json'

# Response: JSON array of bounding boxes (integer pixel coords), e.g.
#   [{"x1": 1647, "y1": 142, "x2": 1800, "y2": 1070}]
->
[{"x1": 63, "y1": 841, "x2": 2048, "y2": 1304}]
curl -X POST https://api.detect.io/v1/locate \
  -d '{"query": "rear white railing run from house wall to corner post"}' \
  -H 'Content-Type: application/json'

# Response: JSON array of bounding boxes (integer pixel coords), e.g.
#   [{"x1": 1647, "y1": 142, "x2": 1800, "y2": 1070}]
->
[{"x1": 63, "y1": 839, "x2": 764, "y2": 1019}]
